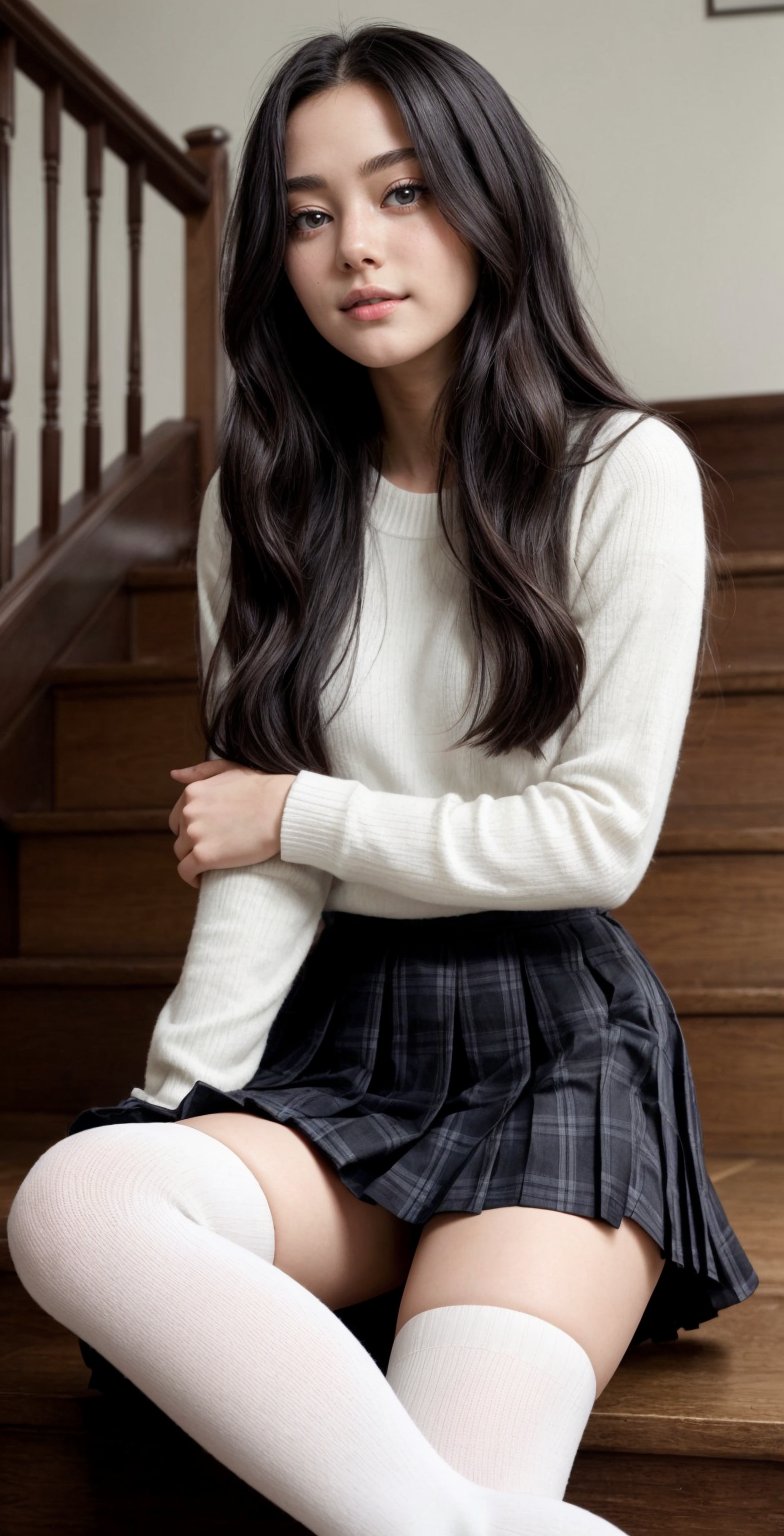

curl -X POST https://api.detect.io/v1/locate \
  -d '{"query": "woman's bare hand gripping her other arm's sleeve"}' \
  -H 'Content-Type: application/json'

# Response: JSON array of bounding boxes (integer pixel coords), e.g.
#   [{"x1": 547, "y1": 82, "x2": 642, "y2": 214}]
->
[{"x1": 169, "y1": 757, "x2": 297, "y2": 889}]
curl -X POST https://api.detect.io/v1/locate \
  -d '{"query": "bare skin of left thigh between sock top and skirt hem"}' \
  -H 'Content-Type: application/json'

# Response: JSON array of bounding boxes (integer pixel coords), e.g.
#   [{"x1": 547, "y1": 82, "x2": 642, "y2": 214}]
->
[{"x1": 174, "y1": 1111, "x2": 420, "y2": 1312}]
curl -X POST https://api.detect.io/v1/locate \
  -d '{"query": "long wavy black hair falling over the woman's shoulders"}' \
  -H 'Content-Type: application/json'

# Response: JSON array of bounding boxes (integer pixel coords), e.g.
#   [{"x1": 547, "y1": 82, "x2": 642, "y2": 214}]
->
[{"x1": 200, "y1": 23, "x2": 718, "y2": 774}]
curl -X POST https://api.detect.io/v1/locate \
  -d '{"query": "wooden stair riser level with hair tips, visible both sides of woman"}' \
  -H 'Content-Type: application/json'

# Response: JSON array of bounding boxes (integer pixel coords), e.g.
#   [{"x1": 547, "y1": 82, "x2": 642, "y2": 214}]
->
[{"x1": 54, "y1": 682, "x2": 784, "y2": 811}]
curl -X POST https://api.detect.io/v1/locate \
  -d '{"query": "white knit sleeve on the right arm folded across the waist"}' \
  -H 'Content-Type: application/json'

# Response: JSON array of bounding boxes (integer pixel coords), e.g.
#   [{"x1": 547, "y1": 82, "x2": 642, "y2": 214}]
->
[{"x1": 281, "y1": 418, "x2": 706, "y2": 909}]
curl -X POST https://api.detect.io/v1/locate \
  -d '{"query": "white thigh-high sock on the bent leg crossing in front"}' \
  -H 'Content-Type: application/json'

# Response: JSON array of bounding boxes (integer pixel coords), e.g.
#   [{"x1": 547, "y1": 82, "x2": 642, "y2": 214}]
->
[{"x1": 8, "y1": 1121, "x2": 623, "y2": 1536}]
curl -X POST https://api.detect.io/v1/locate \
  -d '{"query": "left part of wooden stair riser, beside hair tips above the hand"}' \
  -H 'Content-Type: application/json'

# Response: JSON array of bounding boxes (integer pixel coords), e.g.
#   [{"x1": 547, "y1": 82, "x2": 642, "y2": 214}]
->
[{"x1": 54, "y1": 682, "x2": 206, "y2": 811}]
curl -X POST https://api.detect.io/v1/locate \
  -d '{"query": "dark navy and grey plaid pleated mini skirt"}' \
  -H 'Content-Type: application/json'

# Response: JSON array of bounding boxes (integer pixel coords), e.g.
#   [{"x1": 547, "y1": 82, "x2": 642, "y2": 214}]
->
[{"x1": 68, "y1": 906, "x2": 759, "y2": 1347}]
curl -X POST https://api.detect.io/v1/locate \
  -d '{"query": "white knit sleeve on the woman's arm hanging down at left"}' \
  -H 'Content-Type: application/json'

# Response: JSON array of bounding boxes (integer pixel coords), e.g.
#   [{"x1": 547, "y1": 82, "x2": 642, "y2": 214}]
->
[{"x1": 132, "y1": 473, "x2": 332, "y2": 1109}]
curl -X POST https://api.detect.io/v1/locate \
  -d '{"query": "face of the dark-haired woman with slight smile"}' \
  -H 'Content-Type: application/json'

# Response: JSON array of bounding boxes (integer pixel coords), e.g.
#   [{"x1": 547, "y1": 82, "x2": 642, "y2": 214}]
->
[{"x1": 284, "y1": 83, "x2": 480, "y2": 369}]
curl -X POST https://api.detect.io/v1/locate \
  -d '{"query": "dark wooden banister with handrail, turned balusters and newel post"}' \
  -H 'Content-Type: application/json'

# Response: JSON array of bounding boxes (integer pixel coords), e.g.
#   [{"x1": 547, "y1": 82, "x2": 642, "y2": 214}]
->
[{"x1": 0, "y1": 0, "x2": 229, "y2": 592}]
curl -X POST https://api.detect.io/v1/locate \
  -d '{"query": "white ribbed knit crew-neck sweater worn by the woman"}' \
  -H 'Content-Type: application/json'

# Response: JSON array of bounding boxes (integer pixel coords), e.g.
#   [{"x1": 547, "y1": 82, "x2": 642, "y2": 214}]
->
[{"x1": 132, "y1": 412, "x2": 706, "y2": 1107}]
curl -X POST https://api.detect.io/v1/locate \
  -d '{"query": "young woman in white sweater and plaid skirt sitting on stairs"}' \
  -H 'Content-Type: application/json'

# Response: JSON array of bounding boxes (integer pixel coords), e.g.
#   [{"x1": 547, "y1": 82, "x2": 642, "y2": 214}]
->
[{"x1": 9, "y1": 25, "x2": 758, "y2": 1536}]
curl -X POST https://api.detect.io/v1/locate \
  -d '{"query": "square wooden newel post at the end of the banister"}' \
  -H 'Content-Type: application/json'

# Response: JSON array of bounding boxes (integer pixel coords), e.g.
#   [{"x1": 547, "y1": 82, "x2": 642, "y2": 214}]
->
[{"x1": 183, "y1": 127, "x2": 229, "y2": 492}]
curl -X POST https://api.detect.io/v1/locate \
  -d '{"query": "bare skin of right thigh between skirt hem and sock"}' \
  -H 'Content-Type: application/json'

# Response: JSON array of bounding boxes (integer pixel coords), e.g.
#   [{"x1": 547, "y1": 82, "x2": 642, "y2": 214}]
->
[{"x1": 395, "y1": 1206, "x2": 664, "y2": 1396}]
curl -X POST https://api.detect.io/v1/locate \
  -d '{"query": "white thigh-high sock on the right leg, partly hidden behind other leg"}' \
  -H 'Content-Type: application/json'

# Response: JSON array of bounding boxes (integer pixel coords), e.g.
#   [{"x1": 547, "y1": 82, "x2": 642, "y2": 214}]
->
[{"x1": 386, "y1": 1306, "x2": 596, "y2": 1499}]
